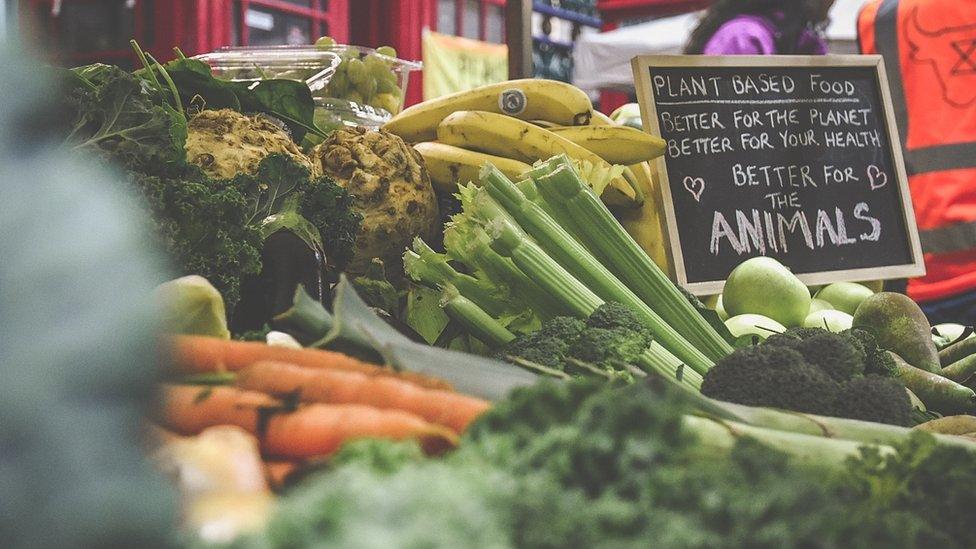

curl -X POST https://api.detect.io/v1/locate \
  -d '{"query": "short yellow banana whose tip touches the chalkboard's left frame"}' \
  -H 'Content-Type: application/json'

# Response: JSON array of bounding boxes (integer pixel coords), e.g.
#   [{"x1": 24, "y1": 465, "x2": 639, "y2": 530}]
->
[{"x1": 551, "y1": 126, "x2": 667, "y2": 166}]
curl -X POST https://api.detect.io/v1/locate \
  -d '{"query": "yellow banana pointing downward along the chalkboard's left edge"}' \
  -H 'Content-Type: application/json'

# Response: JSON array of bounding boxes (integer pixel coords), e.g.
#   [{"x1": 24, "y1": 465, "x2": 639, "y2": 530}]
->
[{"x1": 619, "y1": 163, "x2": 673, "y2": 275}]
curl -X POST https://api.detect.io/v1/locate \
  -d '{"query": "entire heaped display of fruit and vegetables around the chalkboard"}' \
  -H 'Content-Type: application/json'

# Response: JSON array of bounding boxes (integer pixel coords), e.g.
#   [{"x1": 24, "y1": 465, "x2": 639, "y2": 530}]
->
[{"x1": 40, "y1": 42, "x2": 976, "y2": 547}]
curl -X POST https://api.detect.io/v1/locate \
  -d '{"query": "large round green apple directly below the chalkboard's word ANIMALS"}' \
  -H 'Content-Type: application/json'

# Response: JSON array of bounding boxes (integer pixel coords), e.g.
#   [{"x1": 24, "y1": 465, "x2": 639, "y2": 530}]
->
[{"x1": 722, "y1": 257, "x2": 810, "y2": 327}]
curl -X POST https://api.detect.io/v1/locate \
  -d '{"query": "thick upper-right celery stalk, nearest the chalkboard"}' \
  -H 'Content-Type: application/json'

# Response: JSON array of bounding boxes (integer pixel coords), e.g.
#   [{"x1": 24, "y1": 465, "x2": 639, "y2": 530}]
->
[{"x1": 532, "y1": 165, "x2": 732, "y2": 361}]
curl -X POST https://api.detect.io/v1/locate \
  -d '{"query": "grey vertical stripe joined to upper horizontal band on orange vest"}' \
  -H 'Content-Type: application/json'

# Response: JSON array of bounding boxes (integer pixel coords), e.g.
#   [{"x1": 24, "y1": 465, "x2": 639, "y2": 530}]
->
[{"x1": 874, "y1": 0, "x2": 976, "y2": 176}]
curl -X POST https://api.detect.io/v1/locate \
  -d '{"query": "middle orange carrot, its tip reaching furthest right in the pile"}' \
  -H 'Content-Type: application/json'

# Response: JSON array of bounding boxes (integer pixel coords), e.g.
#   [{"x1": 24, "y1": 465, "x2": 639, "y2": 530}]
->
[{"x1": 236, "y1": 361, "x2": 490, "y2": 434}]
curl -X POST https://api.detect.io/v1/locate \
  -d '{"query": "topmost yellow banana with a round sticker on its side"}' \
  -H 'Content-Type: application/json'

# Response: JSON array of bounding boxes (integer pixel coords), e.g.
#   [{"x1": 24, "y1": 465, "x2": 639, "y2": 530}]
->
[{"x1": 383, "y1": 79, "x2": 593, "y2": 143}]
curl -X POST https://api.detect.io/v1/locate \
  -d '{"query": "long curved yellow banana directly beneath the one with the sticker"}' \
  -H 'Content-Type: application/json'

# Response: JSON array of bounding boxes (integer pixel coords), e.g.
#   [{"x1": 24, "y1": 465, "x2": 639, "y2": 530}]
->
[{"x1": 437, "y1": 111, "x2": 643, "y2": 207}]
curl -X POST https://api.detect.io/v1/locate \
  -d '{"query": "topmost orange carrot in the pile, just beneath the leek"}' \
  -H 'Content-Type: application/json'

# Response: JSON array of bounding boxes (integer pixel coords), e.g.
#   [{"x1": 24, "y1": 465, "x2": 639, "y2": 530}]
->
[{"x1": 170, "y1": 335, "x2": 451, "y2": 390}]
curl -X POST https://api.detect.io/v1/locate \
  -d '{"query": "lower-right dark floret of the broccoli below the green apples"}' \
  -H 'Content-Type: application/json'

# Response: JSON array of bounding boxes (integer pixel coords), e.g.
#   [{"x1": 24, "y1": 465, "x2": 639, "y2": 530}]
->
[{"x1": 832, "y1": 375, "x2": 912, "y2": 427}]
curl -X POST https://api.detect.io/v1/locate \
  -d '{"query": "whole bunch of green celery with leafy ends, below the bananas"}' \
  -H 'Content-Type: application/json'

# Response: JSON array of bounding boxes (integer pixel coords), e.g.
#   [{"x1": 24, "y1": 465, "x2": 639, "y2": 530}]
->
[{"x1": 404, "y1": 156, "x2": 731, "y2": 388}]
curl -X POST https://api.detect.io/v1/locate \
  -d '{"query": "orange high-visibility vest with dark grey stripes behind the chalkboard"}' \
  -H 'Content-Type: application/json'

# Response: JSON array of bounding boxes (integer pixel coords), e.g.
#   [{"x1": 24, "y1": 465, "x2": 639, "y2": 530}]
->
[{"x1": 858, "y1": 0, "x2": 976, "y2": 302}]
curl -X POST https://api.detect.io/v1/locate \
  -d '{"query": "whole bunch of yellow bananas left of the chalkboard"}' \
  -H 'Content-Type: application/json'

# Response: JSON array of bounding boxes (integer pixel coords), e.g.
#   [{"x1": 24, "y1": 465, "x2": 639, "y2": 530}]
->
[{"x1": 384, "y1": 79, "x2": 670, "y2": 272}]
